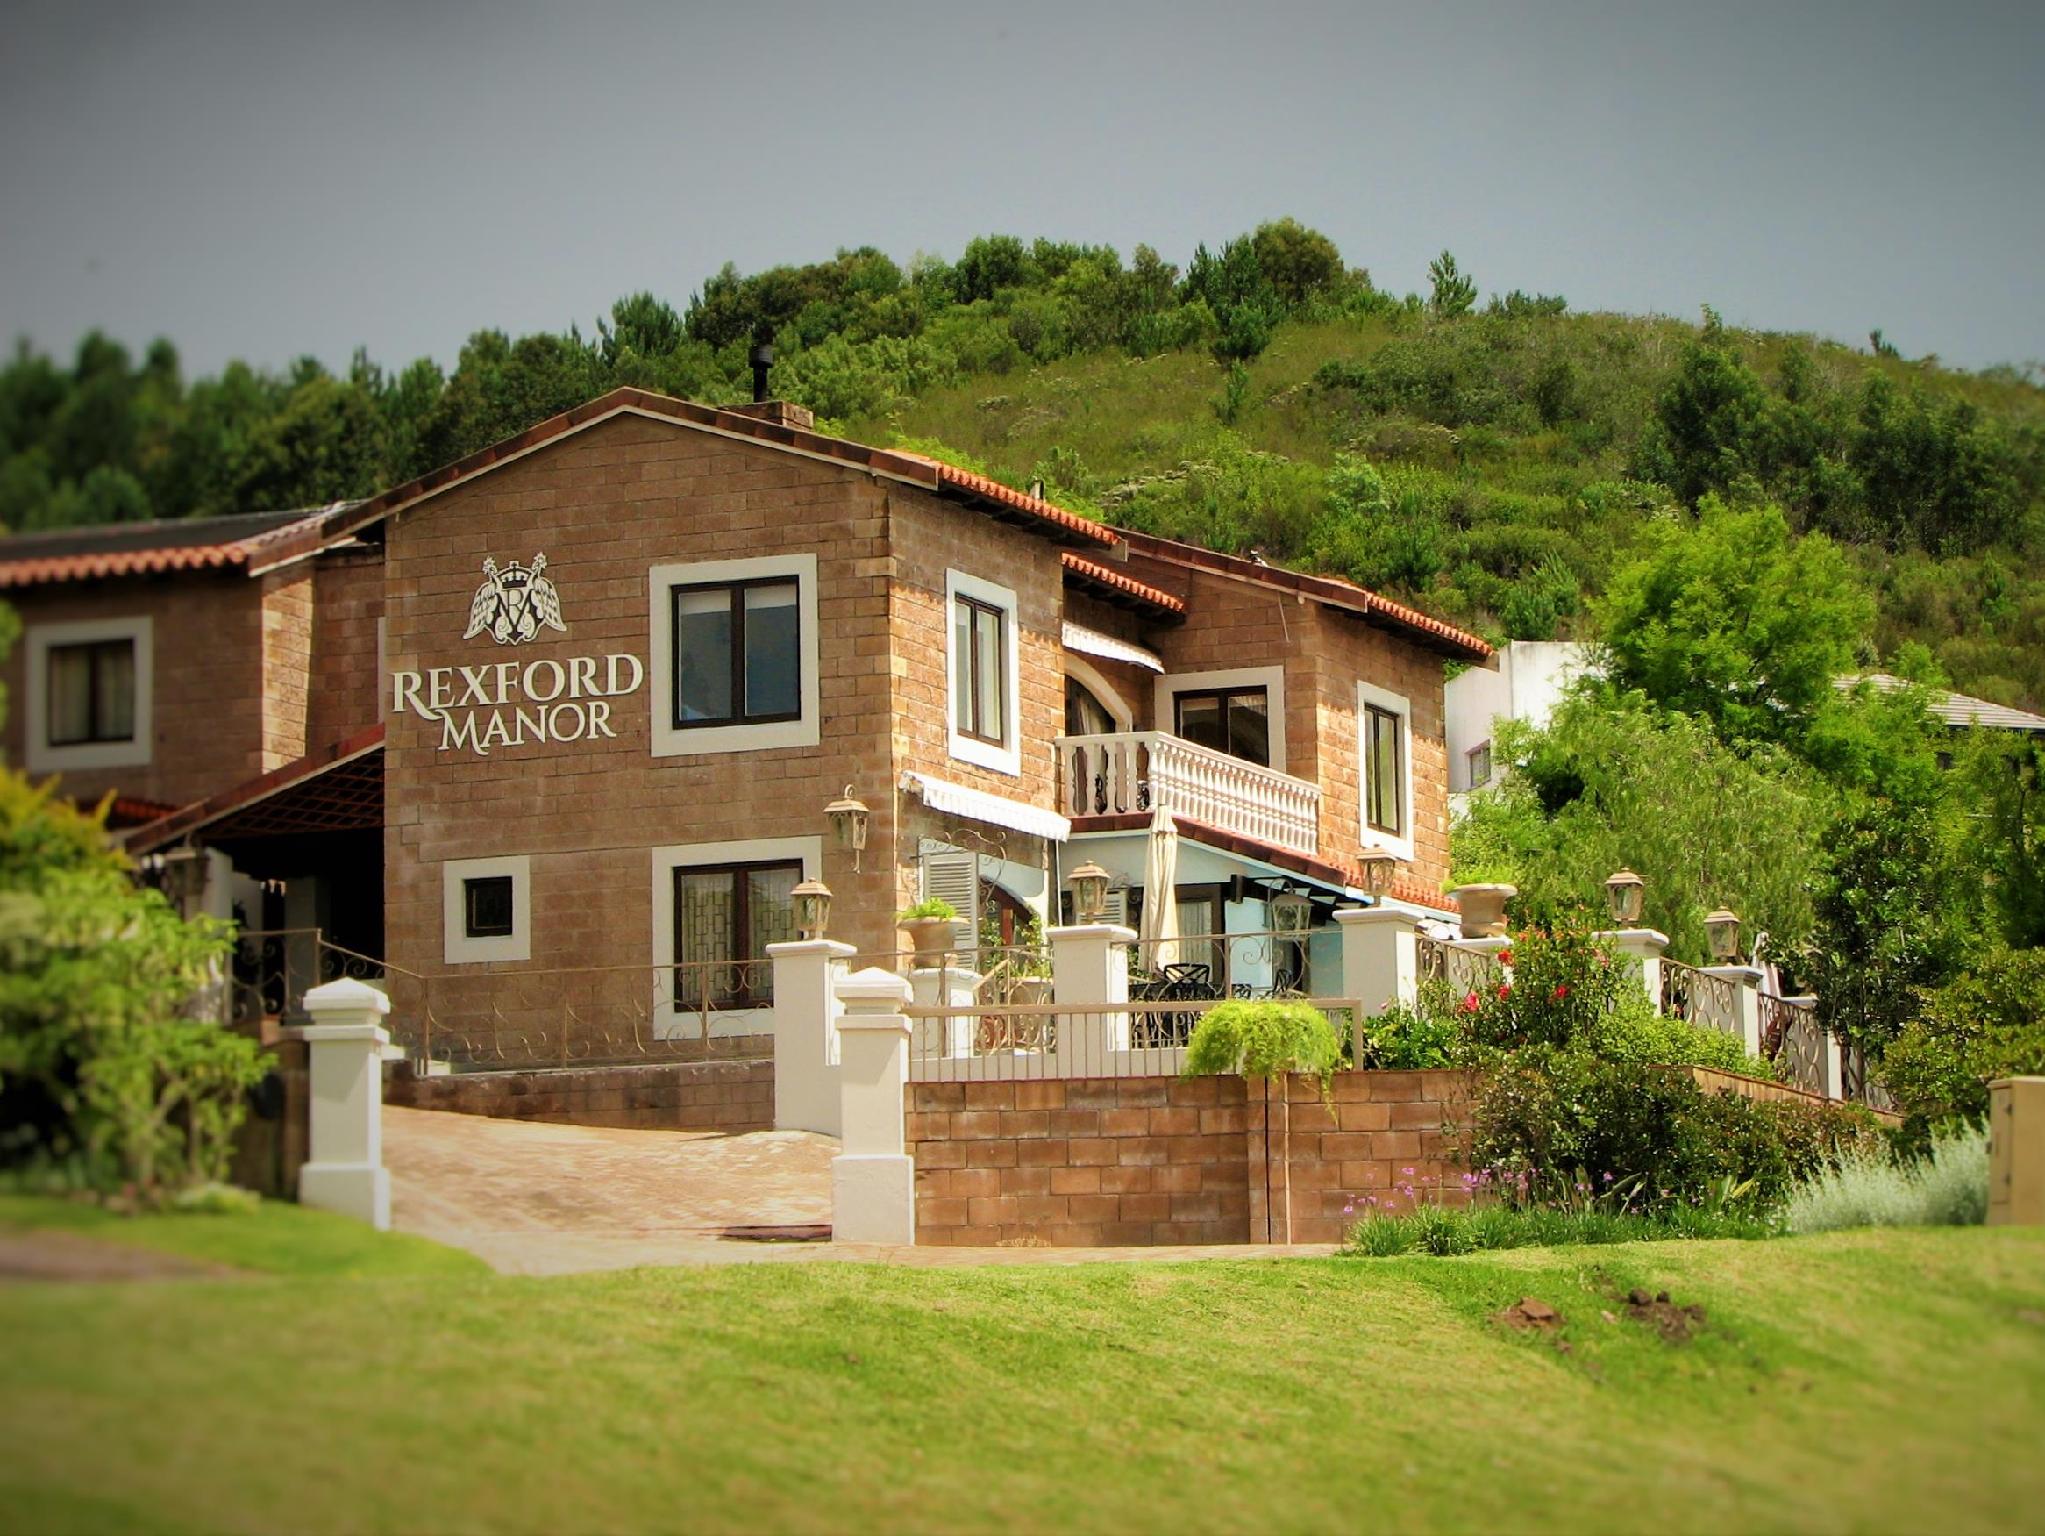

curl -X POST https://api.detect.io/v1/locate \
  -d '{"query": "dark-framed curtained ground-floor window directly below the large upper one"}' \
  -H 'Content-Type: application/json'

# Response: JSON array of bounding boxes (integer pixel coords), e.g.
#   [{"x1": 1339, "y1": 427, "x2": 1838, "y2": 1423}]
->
[{"x1": 675, "y1": 859, "x2": 802, "y2": 1008}]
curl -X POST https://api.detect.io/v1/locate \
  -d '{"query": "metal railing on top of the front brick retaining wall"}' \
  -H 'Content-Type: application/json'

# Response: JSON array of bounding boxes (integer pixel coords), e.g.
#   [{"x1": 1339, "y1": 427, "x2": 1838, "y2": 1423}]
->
[{"x1": 904, "y1": 998, "x2": 1354, "y2": 1082}]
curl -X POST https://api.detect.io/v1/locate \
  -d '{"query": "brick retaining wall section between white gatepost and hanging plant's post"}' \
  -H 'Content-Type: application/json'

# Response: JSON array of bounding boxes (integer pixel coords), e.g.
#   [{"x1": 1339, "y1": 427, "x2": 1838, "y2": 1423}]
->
[{"x1": 908, "y1": 1078, "x2": 1249, "y2": 1248}]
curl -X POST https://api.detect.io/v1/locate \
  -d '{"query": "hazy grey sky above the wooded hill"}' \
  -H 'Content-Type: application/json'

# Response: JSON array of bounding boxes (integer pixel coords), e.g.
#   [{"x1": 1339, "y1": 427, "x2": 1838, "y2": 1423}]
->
[{"x1": 0, "y1": 0, "x2": 2045, "y2": 374}]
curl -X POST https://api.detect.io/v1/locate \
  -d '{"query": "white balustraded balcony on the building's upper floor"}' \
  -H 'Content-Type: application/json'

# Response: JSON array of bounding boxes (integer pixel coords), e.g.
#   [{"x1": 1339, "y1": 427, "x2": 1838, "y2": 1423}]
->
[{"x1": 1057, "y1": 730, "x2": 1321, "y2": 855}]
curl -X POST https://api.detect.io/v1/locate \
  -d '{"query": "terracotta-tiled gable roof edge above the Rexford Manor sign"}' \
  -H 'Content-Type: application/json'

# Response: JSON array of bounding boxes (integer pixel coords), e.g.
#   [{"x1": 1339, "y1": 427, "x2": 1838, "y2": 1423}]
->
[{"x1": 327, "y1": 389, "x2": 1119, "y2": 548}]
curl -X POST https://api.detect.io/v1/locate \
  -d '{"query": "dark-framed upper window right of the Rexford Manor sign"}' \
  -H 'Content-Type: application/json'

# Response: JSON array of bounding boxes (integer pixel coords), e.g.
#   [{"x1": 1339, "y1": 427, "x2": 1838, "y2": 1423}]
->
[{"x1": 671, "y1": 579, "x2": 802, "y2": 730}]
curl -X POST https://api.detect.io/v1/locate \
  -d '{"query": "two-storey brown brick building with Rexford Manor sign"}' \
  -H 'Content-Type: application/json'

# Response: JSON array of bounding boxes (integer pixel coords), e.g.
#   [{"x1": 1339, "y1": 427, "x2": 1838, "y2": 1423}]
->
[{"x1": 0, "y1": 391, "x2": 1489, "y2": 1055}]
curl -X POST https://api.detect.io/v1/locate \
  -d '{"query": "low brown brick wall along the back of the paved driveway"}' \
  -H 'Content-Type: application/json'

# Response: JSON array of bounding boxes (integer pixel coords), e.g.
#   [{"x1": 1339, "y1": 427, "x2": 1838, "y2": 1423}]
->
[{"x1": 384, "y1": 1059, "x2": 773, "y2": 1133}]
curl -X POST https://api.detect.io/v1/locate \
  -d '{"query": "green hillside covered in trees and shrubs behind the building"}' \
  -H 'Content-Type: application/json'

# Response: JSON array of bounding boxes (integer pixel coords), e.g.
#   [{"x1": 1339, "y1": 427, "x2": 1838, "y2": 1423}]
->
[{"x1": 0, "y1": 221, "x2": 2045, "y2": 706}]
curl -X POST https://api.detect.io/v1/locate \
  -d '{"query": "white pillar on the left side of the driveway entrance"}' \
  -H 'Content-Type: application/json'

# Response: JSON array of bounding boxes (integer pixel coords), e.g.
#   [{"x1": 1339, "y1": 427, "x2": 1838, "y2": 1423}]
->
[{"x1": 299, "y1": 980, "x2": 391, "y2": 1231}]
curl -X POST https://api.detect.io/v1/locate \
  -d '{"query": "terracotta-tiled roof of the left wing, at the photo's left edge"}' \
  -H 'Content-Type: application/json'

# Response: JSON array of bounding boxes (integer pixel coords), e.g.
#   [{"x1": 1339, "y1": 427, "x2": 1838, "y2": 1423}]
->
[{"x1": 0, "y1": 503, "x2": 339, "y2": 589}]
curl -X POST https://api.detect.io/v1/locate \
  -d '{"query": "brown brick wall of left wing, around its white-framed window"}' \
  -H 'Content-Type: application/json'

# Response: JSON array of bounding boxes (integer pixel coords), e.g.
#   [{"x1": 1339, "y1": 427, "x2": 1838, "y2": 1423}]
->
[{"x1": 0, "y1": 573, "x2": 268, "y2": 806}]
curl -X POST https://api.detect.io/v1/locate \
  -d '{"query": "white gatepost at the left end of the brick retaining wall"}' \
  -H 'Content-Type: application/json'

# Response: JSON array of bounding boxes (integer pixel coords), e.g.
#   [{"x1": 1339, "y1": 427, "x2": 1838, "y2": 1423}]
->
[{"x1": 830, "y1": 967, "x2": 916, "y2": 1244}]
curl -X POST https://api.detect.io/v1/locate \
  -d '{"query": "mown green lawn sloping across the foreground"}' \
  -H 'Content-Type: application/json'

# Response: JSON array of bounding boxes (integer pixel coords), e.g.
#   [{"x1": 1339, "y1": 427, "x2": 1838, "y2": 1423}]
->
[{"x1": 0, "y1": 1201, "x2": 2045, "y2": 1532}]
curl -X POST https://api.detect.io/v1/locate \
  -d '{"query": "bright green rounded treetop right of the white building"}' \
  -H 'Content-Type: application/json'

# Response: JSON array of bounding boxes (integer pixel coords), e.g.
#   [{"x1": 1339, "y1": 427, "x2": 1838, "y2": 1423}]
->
[{"x1": 1595, "y1": 497, "x2": 1873, "y2": 742}]
